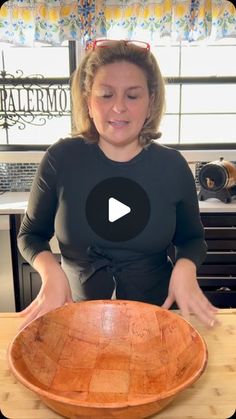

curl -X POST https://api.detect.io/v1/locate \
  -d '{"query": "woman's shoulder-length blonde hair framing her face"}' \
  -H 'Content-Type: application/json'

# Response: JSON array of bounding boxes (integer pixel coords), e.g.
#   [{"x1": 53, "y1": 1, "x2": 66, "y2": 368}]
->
[{"x1": 71, "y1": 41, "x2": 165, "y2": 147}]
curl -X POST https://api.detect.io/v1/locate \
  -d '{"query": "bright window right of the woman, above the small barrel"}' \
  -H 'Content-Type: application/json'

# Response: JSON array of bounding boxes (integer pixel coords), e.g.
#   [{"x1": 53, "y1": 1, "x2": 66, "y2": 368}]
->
[{"x1": 153, "y1": 39, "x2": 236, "y2": 148}]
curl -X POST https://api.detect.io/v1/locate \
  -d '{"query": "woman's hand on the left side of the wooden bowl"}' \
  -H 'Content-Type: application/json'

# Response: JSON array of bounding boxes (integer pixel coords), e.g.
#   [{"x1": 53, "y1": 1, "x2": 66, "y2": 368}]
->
[{"x1": 19, "y1": 253, "x2": 73, "y2": 329}]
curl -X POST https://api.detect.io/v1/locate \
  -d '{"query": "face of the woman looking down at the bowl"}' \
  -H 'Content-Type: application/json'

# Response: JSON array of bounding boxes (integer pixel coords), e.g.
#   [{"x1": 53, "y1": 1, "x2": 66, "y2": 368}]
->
[{"x1": 88, "y1": 61, "x2": 151, "y2": 146}]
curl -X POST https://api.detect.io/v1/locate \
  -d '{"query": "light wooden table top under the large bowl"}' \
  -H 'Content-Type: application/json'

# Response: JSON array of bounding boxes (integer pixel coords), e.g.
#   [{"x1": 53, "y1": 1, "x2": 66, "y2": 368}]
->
[{"x1": 0, "y1": 309, "x2": 236, "y2": 419}]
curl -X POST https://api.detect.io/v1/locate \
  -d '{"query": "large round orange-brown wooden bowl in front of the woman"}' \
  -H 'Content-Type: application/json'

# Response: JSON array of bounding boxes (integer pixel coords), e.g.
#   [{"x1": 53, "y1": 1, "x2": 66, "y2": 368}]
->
[{"x1": 8, "y1": 300, "x2": 207, "y2": 419}]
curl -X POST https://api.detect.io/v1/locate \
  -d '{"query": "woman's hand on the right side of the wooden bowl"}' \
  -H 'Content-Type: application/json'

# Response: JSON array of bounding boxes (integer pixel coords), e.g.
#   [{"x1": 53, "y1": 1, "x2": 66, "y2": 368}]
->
[{"x1": 162, "y1": 259, "x2": 218, "y2": 327}]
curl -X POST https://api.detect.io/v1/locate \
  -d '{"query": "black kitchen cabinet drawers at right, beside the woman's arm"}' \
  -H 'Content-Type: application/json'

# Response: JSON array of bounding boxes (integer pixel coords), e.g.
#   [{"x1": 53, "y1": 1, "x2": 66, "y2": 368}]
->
[{"x1": 198, "y1": 212, "x2": 236, "y2": 307}]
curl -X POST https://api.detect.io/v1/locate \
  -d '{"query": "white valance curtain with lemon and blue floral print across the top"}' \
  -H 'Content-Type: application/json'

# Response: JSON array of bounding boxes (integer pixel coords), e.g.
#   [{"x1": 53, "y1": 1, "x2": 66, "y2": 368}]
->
[{"x1": 0, "y1": 0, "x2": 236, "y2": 45}]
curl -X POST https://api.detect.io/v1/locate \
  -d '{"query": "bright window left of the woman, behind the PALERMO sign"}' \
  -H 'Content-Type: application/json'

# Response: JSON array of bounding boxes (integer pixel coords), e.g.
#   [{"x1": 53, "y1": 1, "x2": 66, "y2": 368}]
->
[{"x1": 0, "y1": 42, "x2": 73, "y2": 146}]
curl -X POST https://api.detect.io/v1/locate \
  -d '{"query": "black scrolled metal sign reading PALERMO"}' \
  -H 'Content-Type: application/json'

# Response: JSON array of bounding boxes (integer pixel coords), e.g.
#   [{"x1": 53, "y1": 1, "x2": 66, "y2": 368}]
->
[{"x1": 0, "y1": 51, "x2": 71, "y2": 142}]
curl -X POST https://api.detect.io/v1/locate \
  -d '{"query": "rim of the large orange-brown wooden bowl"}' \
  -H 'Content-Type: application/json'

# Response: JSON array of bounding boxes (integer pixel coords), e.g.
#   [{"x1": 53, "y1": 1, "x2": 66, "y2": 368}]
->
[{"x1": 7, "y1": 300, "x2": 208, "y2": 409}]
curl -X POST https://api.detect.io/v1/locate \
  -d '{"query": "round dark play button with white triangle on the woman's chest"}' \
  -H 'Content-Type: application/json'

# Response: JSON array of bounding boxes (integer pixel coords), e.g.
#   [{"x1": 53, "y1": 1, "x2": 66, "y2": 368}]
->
[{"x1": 86, "y1": 177, "x2": 150, "y2": 242}]
